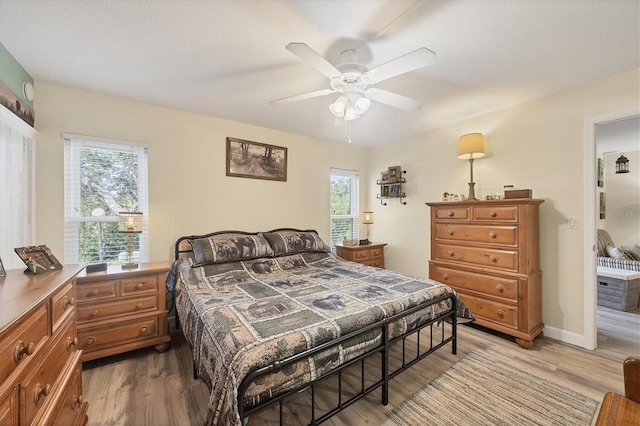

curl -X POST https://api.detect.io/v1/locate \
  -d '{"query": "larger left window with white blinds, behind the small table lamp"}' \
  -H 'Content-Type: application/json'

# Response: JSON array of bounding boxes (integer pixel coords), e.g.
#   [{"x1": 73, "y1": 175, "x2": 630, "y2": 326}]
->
[{"x1": 64, "y1": 134, "x2": 149, "y2": 263}]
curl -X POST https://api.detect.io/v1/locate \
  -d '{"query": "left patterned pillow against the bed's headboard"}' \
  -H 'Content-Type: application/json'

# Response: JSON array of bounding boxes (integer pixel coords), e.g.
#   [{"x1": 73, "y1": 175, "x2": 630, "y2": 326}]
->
[{"x1": 189, "y1": 233, "x2": 273, "y2": 268}]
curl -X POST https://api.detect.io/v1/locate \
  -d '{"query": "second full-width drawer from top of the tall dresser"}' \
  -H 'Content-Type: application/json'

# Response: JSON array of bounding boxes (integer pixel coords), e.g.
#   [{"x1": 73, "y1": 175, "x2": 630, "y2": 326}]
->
[{"x1": 435, "y1": 244, "x2": 518, "y2": 272}]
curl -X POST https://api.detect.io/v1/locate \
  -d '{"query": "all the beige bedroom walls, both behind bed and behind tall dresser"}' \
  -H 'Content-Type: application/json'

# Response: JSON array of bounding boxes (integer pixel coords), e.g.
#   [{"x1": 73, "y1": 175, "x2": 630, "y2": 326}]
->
[{"x1": 36, "y1": 69, "x2": 640, "y2": 346}]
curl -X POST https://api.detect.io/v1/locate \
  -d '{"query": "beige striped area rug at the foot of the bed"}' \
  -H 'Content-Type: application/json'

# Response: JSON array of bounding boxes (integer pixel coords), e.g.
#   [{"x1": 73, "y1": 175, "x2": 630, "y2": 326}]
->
[{"x1": 387, "y1": 352, "x2": 598, "y2": 426}]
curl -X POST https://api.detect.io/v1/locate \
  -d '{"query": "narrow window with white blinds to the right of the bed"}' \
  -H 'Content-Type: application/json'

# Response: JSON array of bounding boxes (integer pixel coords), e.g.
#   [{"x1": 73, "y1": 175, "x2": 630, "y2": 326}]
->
[{"x1": 330, "y1": 169, "x2": 360, "y2": 252}]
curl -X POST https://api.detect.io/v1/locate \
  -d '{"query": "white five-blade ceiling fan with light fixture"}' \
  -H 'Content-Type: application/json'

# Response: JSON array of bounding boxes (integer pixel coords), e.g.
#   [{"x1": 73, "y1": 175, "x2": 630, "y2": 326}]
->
[{"x1": 269, "y1": 43, "x2": 436, "y2": 121}]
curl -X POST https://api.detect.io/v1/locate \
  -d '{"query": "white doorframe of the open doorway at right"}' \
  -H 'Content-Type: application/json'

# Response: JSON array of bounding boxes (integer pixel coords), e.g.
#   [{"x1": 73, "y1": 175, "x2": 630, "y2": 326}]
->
[{"x1": 583, "y1": 107, "x2": 640, "y2": 350}]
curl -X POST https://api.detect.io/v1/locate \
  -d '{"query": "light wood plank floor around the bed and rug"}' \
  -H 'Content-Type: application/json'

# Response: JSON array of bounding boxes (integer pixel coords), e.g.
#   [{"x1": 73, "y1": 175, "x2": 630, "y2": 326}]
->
[{"x1": 83, "y1": 326, "x2": 640, "y2": 426}]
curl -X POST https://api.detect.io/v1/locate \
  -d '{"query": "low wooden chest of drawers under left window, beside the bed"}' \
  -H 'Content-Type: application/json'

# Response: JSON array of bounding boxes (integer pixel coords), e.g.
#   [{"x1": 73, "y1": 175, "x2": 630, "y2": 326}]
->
[{"x1": 77, "y1": 262, "x2": 171, "y2": 361}]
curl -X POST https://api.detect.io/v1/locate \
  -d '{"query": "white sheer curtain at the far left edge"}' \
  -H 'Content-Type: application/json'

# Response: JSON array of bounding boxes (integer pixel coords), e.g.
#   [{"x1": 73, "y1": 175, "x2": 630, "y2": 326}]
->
[{"x1": 0, "y1": 105, "x2": 36, "y2": 269}]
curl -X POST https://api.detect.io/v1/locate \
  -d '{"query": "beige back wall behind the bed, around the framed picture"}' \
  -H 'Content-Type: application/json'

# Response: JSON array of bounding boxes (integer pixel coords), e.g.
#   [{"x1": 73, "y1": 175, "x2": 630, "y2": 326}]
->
[{"x1": 36, "y1": 82, "x2": 367, "y2": 261}]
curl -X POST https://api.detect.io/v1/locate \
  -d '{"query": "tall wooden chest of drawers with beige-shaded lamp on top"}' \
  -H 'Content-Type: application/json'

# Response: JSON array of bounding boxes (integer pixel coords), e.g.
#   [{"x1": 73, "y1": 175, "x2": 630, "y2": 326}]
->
[{"x1": 427, "y1": 198, "x2": 544, "y2": 349}]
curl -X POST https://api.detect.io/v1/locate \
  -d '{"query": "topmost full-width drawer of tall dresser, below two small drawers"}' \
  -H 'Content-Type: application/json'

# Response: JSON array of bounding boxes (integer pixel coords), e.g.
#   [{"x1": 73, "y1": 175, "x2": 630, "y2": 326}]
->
[{"x1": 436, "y1": 223, "x2": 518, "y2": 247}]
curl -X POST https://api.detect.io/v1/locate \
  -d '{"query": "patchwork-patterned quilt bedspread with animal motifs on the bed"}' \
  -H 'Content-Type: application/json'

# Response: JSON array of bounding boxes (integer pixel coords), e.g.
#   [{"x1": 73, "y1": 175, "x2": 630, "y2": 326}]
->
[{"x1": 168, "y1": 253, "x2": 472, "y2": 425}]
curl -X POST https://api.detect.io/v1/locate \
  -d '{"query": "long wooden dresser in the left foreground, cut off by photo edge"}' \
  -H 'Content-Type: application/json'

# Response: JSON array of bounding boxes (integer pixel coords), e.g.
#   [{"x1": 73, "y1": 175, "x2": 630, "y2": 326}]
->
[{"x1": 0, "y1": 265, "x2": 88, "y2": 426}]
